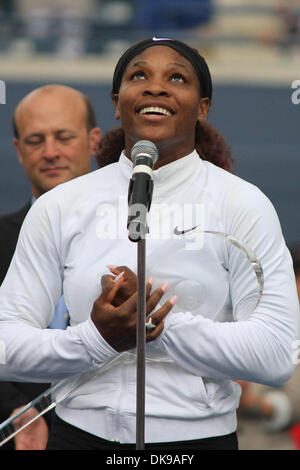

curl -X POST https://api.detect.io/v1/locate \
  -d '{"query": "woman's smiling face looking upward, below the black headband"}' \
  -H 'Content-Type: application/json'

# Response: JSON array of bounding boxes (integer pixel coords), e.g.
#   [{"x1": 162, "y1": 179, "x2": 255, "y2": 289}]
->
[{"x1": 113, "y1": 46, "x2": 209, "y2": 167}]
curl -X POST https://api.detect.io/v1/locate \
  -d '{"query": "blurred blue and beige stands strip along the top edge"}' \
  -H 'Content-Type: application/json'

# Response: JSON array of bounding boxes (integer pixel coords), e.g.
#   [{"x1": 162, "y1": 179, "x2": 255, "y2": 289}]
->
[{"x1": 0, "y1": 0, "x2": 300, "y2": 58}]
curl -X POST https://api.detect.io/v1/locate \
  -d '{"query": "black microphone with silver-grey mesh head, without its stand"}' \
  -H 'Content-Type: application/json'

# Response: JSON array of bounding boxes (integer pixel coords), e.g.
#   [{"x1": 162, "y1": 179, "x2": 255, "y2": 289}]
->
[{"x1": 127, "y1": 140, "x2": 158, "y2": 242}]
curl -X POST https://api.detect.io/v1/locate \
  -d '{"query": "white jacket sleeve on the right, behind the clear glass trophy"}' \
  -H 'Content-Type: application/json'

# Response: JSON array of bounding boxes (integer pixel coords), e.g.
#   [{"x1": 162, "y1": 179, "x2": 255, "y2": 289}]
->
[{"x1": 156, "y1": 183, "x2": 299, "y2": 386}]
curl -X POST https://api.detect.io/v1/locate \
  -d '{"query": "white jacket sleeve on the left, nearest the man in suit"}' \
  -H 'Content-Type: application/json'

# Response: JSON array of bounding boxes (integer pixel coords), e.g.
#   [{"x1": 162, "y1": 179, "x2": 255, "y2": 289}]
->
[{"x1": 0, "y1": 194, "x2": 117, "y2": 382}]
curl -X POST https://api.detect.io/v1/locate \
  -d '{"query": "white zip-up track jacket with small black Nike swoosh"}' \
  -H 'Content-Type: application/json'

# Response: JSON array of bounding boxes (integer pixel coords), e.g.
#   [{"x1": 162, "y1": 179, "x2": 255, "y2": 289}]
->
[{"x1": 0, "y1": 151, "x2": 299, "y2": 442}]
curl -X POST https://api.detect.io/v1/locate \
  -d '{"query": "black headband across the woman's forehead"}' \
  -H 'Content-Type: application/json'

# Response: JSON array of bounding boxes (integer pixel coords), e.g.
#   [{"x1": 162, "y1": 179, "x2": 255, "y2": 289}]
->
[{"x1": 112, "y1": 38, "x2": 212, "y2": 100}]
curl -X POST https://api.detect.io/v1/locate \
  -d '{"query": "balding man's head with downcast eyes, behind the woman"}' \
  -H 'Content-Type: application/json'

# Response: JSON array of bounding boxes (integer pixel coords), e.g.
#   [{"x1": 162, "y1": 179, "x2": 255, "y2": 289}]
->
[{"x1": 13, "y1": 85, "x2": 101, "y2": 197}]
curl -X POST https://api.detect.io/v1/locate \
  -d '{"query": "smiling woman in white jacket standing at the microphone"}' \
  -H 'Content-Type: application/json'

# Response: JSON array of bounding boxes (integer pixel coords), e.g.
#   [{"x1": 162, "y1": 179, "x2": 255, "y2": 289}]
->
[{"x1": 0, "y1": 38, "x2": 299, "y2": 450}]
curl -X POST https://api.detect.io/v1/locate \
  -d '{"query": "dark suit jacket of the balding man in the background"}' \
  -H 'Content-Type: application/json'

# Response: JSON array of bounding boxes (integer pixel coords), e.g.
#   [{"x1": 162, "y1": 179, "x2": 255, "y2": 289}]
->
[{"x1": 0, "y1": 202, "x2": 50, "y2": 449}]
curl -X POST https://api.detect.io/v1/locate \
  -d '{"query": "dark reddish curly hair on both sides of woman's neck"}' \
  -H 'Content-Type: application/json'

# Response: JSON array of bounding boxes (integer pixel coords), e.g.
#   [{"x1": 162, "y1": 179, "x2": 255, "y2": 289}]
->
[{"x1": 96, "y1": 121, "x2": 234, "y2": 172}]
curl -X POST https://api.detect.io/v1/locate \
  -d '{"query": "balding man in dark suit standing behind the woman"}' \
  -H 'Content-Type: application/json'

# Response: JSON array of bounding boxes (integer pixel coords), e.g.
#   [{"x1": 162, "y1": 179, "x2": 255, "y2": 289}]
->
[{"x1": 0, "y1": 85, "x2": 101, "y2": 450}]
